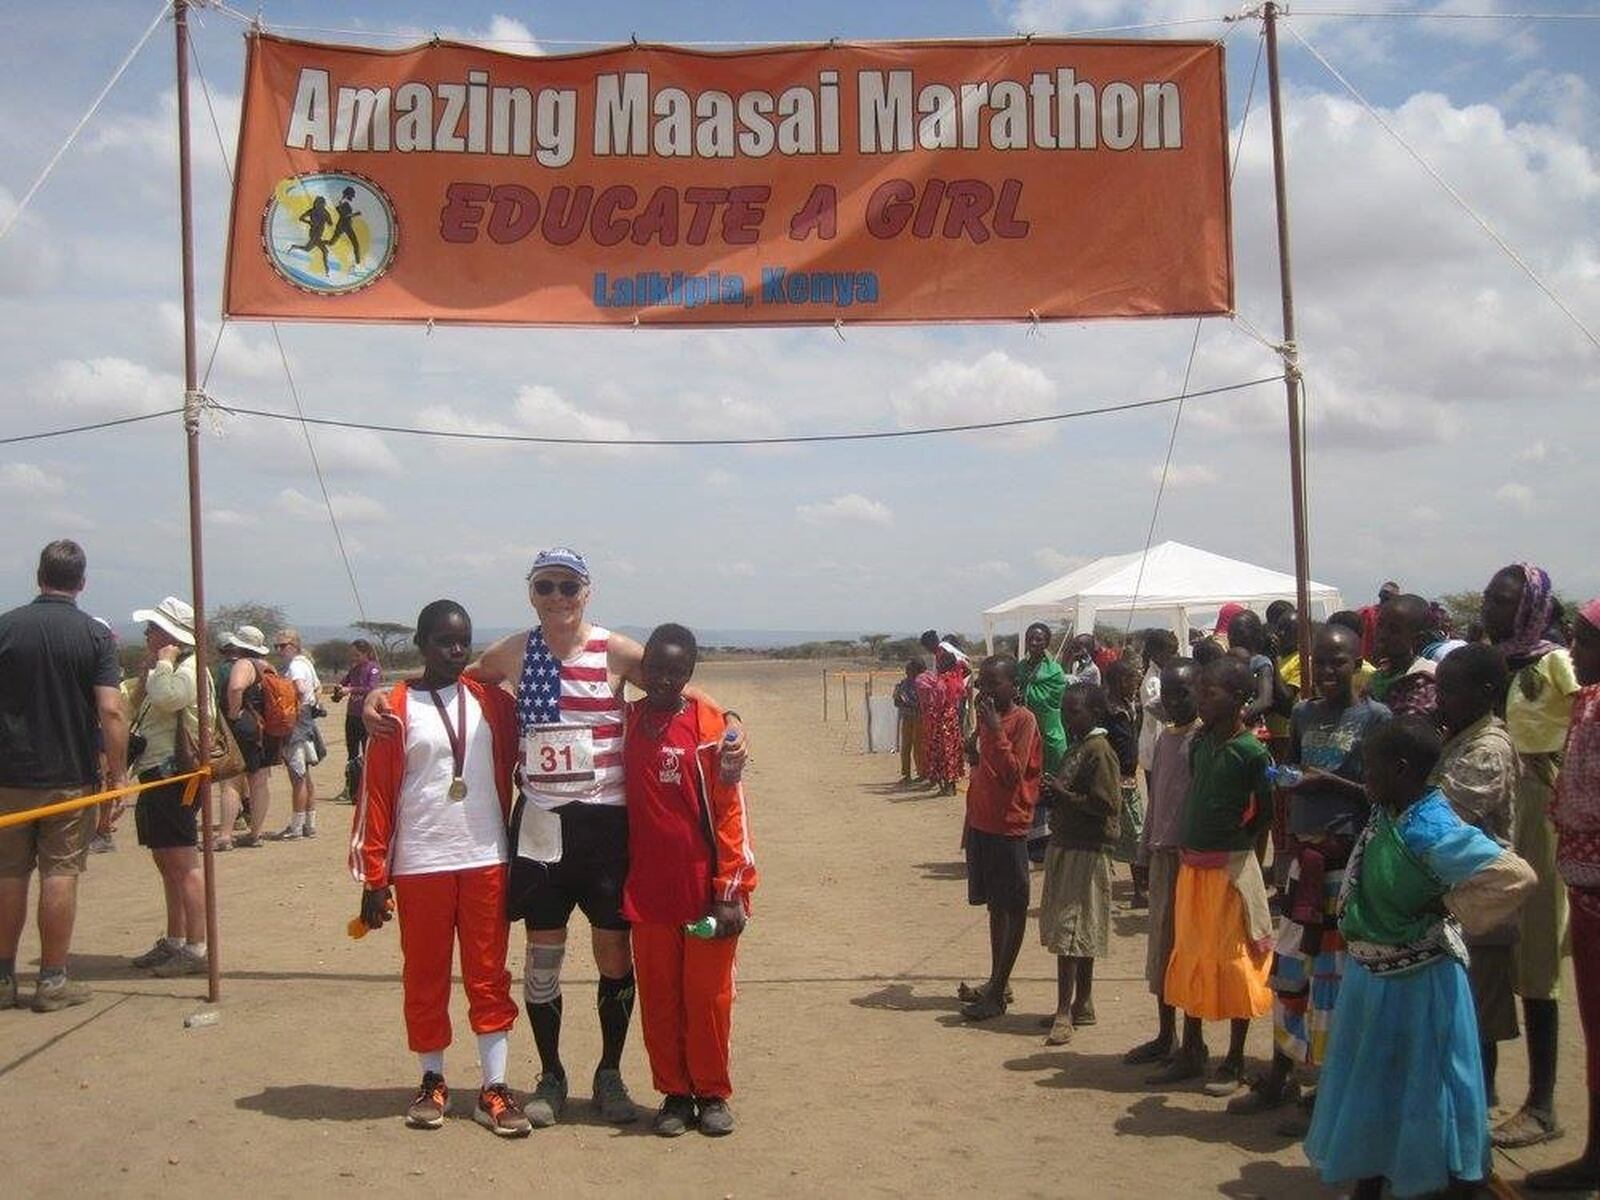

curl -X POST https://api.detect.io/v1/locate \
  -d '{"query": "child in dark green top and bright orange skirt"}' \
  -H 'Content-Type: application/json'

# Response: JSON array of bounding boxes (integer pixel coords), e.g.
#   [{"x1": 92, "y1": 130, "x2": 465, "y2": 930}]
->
[{"x1": 1150, "y1": 656, "x2": 1272, "y2": 1096}]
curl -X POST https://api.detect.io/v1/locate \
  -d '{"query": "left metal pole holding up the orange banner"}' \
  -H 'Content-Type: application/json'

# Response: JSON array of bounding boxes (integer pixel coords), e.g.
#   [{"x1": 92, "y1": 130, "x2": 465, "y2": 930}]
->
[{"x1": 173, "y1": 0, "x2": 222, "y2": 1003}]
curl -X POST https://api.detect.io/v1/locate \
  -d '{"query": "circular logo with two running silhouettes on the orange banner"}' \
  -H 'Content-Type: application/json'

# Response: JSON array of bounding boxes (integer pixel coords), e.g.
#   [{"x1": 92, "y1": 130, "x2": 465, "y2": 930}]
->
[{"x1": 261, "y1": 171, "x2": 400, "y2": 296}]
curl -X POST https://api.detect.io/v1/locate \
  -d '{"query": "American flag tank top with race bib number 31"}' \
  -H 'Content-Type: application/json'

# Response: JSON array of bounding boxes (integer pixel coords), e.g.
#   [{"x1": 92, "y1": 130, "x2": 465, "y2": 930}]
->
[{"x1": 517, "y1": 626, "x2": 627, "y2": 808}]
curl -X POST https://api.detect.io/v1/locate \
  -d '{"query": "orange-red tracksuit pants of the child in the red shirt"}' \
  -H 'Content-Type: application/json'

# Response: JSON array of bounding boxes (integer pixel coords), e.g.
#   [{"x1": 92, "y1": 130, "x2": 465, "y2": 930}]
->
[{"x1": 634, "y1": 922, "x2": 739, "y2": 1099}]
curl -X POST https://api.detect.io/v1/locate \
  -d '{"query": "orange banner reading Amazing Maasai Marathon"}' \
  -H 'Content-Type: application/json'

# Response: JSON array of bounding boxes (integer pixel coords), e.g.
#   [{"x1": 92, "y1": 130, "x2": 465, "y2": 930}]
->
[{"x1": 224, "y1": 35, "x2": 1234, "y2": 325}]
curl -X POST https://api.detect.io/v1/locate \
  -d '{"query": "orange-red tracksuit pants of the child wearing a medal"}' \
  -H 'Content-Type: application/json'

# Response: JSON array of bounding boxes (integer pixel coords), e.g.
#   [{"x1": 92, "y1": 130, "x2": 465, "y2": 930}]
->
[{"x1": 394, "y1": 864, "x2": 517, "y2": 1054}]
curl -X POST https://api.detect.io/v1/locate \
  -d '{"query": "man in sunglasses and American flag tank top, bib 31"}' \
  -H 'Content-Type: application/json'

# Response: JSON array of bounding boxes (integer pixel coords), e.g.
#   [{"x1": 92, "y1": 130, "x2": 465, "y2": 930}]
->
[{"x1": 366, "y1": 546, "x2": 746, "y2": 1128}]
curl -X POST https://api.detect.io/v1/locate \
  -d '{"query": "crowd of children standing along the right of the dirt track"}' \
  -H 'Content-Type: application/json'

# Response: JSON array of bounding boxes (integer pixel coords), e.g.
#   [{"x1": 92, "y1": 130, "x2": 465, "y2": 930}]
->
[{"x1": 934, "y1": 563, "x2": 1600, "y2": 1197}]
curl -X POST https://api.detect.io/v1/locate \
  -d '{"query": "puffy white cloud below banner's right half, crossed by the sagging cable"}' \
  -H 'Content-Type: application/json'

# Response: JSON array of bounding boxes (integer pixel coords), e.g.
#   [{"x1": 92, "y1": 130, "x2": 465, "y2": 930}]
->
[{"x1": 893, "y1": 350, "x2": 1056, "y2": 450}]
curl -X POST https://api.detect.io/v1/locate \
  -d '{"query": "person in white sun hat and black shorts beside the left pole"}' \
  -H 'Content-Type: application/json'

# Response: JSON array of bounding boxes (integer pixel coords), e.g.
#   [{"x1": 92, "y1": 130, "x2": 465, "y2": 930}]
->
[{"x1": 123, "y1": 595, "x2": 210, "y2": 976}]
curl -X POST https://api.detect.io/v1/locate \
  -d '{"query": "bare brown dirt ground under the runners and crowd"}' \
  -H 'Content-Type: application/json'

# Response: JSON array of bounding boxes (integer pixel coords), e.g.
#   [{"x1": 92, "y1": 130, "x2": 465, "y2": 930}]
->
[{"x1": 0, "y1": 662, "x2": 1584, "y2": 1197}]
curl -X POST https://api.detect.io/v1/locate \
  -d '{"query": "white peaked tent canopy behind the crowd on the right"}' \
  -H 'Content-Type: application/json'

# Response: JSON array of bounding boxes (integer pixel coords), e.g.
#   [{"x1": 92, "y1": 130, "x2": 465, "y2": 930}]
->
[{"x1": 984, "y1": 542, "x2": 1342, "y2": 650}]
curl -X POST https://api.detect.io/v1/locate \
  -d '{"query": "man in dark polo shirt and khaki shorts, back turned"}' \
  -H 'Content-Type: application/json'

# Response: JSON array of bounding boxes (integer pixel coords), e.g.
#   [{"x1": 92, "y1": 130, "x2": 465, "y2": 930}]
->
[{"x1": 0, "y1": 541, "x2": 128, "y2": 1013}]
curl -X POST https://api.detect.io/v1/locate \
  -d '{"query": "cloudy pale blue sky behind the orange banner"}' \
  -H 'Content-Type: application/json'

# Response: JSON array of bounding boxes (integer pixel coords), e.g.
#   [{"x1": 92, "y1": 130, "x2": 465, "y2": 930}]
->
[{"x1": 0, "y1": 0, "x2": 1600, "y2": 632}]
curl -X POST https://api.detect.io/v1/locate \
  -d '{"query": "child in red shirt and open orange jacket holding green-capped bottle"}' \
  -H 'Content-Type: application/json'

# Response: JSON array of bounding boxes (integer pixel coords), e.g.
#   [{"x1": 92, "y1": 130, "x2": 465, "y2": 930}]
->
[{"x1": 622, "y1": 624, "x2": 755, "y2": 1138}]
